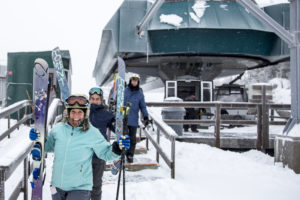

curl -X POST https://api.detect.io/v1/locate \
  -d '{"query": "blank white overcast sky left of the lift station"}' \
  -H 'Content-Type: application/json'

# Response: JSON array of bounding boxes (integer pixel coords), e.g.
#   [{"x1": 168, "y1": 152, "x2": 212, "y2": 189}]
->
[{"x1": 0, "y1": 0, "x2": 122, "y2": 93}]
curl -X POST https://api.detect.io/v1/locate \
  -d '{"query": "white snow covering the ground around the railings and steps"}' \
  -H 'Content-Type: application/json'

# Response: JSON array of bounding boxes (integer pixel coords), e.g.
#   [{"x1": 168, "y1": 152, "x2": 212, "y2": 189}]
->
[{"x1": 0, "y1": 85, "x2": 300, "y2": 200}]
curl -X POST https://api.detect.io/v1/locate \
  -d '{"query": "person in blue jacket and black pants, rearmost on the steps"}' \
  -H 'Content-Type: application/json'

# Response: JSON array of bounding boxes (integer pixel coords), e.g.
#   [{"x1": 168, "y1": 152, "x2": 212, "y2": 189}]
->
[{"x1": 124, "y1": 75, "x2": 149, "y2": 163}]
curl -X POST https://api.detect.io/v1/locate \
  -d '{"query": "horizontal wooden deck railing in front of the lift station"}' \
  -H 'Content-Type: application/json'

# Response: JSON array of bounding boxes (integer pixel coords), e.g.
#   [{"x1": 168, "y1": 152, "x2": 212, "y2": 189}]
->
[{"x1": 147, "y1": 102, "x2": 291, "y2": 150}]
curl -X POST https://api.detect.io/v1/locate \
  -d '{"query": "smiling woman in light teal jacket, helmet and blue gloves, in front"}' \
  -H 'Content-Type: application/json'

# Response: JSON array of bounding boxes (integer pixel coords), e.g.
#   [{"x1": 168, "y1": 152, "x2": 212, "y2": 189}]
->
[{"x1": 30, "y1": 95, "x2": 130, "y2": 200}]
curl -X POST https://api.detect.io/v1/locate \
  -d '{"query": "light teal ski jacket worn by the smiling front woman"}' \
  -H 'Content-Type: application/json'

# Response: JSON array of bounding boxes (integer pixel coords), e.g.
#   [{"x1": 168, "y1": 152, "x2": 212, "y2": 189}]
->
[{"x1": 45, "y1": 123, "x2": 120, "y2": 191}]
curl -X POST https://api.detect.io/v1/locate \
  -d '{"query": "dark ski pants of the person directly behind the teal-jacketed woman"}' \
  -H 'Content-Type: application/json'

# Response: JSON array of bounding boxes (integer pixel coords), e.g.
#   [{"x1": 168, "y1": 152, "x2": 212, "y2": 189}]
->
[{"x1": 91, "y1": 156, "x2": 106, "y2": 200}]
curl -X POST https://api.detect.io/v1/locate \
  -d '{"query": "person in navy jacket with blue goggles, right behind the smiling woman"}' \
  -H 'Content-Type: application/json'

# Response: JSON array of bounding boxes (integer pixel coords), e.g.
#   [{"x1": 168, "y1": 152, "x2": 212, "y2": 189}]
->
[{"x1": 89, "y1": 87, "x2": 115, "y2": 200}]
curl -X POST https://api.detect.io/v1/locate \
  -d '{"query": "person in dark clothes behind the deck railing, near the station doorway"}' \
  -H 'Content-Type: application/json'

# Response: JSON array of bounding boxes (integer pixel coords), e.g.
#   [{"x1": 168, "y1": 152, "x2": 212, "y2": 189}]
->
[{"x1": 183, "y1": 93, "x2": 199, "y2": 133}]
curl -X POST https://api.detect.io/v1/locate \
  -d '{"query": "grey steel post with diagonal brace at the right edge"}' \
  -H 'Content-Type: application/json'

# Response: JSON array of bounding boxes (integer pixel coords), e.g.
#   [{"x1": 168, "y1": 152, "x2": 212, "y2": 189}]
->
[{"x1": 237, "y1": 0, "x2": 300, "y2": 134}]
